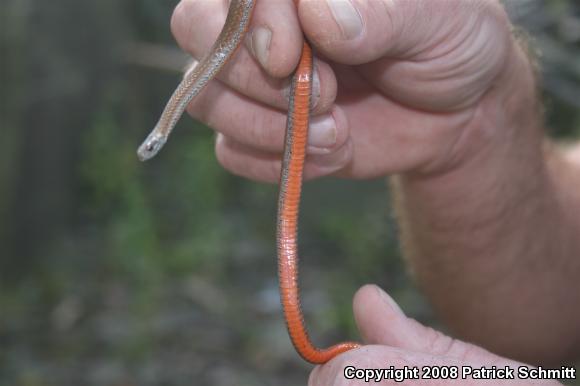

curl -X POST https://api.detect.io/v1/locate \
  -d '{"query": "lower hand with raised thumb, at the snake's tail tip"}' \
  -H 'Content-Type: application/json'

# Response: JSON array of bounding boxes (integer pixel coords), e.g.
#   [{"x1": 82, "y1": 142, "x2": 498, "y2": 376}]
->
[{"x1": 308, "y1": 285, "x2": 559, "y2": 386}]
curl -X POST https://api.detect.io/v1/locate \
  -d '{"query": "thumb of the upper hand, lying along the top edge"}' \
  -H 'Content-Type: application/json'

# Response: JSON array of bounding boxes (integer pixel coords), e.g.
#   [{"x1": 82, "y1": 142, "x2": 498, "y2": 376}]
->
[{"x1": 298, "y1": 0, "x2": 509, "y2": 64}]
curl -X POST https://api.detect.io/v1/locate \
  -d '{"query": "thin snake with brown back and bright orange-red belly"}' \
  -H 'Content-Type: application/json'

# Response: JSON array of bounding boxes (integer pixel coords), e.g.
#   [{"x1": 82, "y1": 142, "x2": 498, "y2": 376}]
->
[{"x1": 137, "y1": 0, "x2": 360, "y2": 364}]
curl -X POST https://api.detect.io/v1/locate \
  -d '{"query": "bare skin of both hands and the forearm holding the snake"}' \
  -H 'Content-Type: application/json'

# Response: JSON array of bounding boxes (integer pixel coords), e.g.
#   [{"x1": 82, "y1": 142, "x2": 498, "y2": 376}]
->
[{"x1": 172, "y1": 0, "x2": 580, "y2": 385}]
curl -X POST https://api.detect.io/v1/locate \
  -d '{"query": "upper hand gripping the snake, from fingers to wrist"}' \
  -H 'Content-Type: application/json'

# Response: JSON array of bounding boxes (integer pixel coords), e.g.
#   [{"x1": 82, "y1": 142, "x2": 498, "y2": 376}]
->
[{"x1": 172, "y1": 0, "x2": 529, "y2": 182}]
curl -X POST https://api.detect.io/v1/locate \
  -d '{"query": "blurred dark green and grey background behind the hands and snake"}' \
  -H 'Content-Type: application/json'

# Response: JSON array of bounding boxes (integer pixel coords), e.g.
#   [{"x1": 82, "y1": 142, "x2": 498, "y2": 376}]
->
[{"x1": 0, "y1": 0, "x2": 580, "y2": 386}]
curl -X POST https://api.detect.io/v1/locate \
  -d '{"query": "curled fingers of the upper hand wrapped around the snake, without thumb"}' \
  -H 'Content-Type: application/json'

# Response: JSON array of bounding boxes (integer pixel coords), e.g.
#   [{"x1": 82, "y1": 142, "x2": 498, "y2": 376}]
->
[{"x1": 172, "y1": 0, "x2": 352, "y2": 182}]
